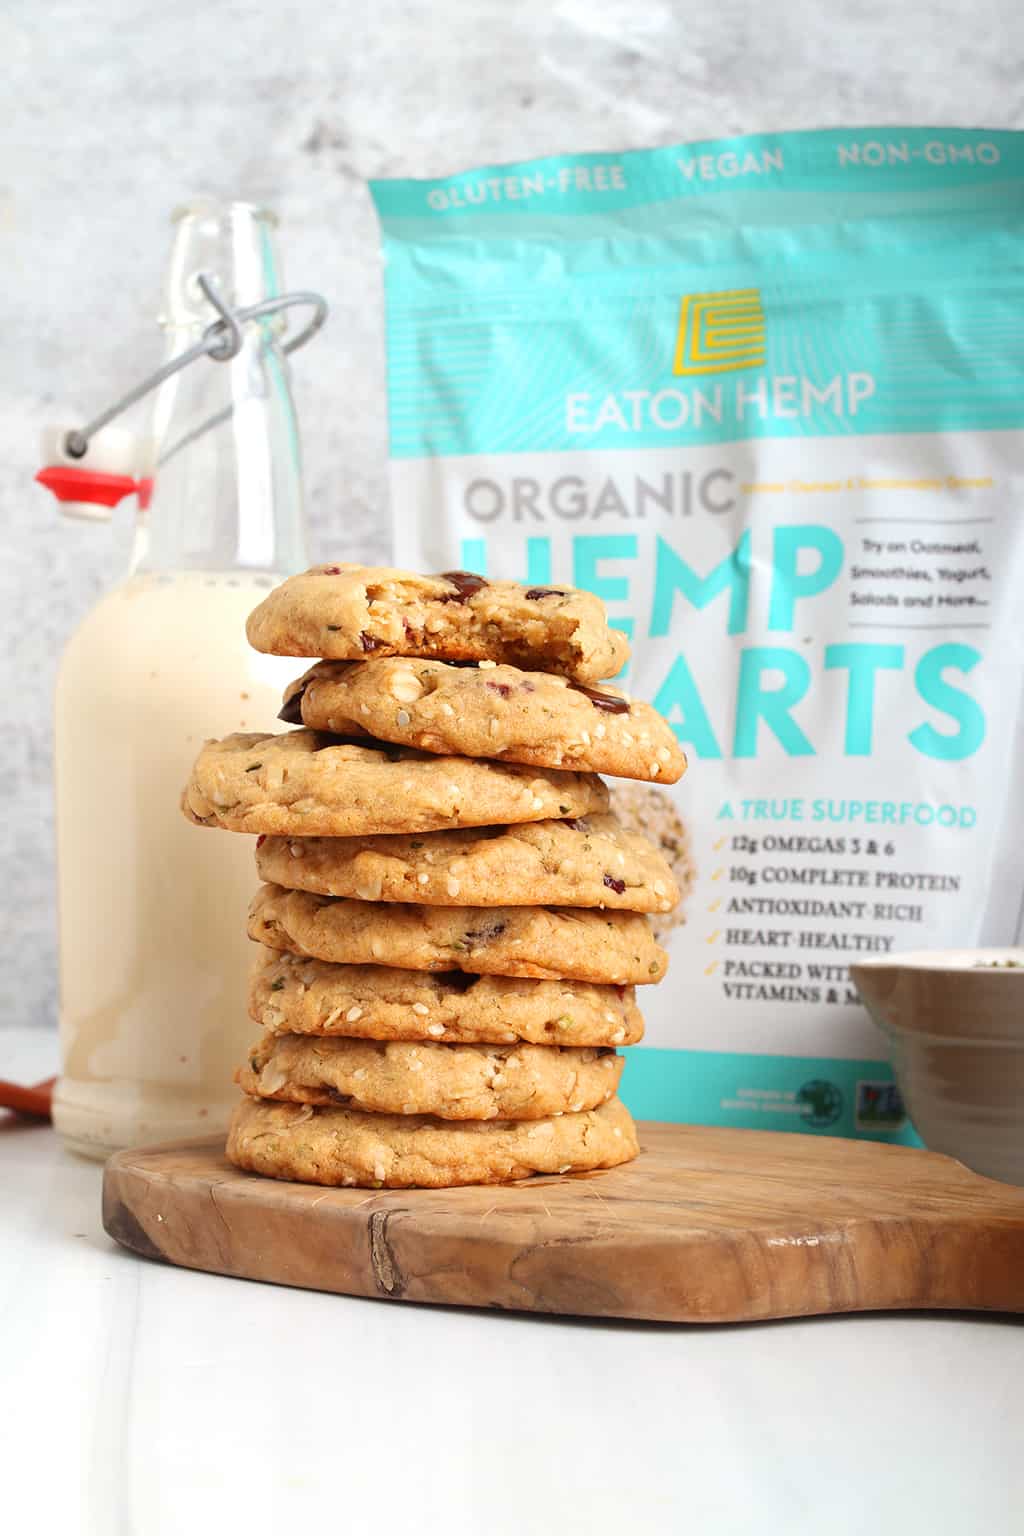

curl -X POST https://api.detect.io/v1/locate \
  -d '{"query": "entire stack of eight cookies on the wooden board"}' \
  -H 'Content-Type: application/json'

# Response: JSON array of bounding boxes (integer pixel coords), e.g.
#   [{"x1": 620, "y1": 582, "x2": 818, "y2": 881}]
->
[{"x1": 184, "y1": 565, "x2": 686, "y2": 1187}]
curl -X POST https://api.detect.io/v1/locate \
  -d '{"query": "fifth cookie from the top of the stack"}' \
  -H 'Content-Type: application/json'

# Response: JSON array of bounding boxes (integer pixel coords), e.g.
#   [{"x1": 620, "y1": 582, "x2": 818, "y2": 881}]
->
[{"x1": 249, "y1": 885, "x2": 668, "y2": 985}]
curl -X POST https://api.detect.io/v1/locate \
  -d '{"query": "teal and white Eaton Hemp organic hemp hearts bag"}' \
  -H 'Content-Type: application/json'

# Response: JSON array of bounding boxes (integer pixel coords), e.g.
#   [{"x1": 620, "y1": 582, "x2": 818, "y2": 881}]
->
[{"x1": 373, "y1": 129, "x2": 1024, "y2": 1140}]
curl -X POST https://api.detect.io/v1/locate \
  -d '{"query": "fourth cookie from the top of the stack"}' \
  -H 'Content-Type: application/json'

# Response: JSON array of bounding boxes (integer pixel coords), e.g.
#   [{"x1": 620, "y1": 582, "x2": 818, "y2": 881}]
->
[{"x1": 256, "y1": 814, "x2": 679, "y2": 912}]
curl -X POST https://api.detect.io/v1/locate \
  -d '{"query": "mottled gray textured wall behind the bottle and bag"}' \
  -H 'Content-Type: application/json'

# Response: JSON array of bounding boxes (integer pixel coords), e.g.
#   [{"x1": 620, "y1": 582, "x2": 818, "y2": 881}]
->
[{"x1": 0, "y1": 0, "x2": 1024, "y2": 1028}]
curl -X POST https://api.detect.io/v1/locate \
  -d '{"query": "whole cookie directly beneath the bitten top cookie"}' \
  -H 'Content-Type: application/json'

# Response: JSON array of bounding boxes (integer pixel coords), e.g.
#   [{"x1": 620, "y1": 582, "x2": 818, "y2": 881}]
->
[{"x1": 281, "y1": 656, "x2": 686, "y2": 783}]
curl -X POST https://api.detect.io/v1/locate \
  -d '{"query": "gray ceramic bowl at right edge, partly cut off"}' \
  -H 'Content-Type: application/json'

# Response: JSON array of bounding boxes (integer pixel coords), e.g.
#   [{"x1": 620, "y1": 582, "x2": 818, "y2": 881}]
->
[{"x1": 851, "y1": 949, "x2": 1024, "y2": 1184}]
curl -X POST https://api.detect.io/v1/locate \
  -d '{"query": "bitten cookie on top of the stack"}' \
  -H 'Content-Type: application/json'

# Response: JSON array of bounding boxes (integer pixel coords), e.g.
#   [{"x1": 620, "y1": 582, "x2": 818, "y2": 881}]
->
[{"x1": 246, "y1": 565, "x2": 629, "y2": 682}]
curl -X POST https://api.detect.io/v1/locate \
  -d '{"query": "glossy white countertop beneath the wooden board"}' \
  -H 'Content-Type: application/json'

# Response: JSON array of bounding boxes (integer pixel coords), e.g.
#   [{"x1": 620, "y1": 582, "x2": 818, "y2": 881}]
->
[{"x1": 0, "y1": 1029, "x2": 1024, "y2": 1536}]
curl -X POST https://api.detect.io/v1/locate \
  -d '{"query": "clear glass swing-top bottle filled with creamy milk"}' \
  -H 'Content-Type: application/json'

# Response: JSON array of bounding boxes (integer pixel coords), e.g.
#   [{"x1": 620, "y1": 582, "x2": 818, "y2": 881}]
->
[{"x1": 54, "y1": 200, "x2": 307, "y2": 1157}]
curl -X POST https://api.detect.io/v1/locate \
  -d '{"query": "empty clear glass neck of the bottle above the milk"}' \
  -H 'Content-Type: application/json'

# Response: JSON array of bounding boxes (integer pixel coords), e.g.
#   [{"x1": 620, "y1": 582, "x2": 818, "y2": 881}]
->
[{"x1": 132, "y1": 203, "x2": 309, "y2": 574}]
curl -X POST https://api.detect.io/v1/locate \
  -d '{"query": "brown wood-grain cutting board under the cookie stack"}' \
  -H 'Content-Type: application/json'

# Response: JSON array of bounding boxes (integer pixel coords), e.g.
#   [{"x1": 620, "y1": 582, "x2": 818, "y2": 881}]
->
[{"x1": 103, "y1": 1121, "x2": 1024, "y2": 1322}]
